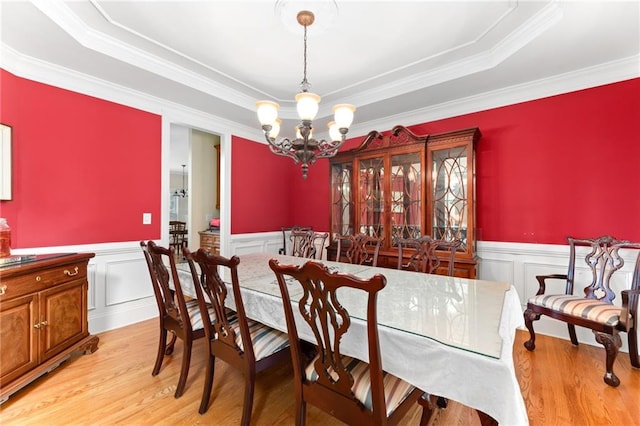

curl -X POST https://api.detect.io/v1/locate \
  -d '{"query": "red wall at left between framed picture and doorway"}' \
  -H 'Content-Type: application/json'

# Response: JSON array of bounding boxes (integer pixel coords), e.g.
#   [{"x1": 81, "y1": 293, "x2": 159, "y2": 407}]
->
[{"x1": 0, "y1": 70, "x2": 161, "y2": 248}]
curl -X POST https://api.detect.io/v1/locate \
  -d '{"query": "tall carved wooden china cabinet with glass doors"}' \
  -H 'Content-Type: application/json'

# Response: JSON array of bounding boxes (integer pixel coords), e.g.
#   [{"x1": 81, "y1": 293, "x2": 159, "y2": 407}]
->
[{"x1": 327, "y1": 126, "x2": 481, "y2": 278}]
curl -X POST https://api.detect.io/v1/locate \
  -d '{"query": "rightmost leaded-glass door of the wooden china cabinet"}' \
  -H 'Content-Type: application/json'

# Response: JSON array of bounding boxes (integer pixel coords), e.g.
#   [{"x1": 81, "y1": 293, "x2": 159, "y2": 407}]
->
[{"x1": 430, "y1": 145, "x2": 471, "y2": 251}]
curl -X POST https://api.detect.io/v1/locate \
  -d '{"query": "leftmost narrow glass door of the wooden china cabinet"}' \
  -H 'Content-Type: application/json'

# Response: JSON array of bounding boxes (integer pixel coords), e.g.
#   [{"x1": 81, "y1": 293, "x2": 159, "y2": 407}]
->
[{"x1": 331, "y1": 162, "x2": 354, "y2": 236}]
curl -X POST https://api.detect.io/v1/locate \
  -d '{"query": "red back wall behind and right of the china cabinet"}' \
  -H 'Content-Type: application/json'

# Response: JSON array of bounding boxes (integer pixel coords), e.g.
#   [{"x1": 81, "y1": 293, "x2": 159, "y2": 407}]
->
[{"x1": 282, "y1": 79, "x2": 640, "y2": 244}]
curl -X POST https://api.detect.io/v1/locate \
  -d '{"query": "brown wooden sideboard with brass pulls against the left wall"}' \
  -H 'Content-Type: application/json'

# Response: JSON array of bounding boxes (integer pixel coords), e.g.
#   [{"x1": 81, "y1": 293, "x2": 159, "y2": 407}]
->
[{"x1": 0, "y1": 253, "x2": 98, "y2": 403}]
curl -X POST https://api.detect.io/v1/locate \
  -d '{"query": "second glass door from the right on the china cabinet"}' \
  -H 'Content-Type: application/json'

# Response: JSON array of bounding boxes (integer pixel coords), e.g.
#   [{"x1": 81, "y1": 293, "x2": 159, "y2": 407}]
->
[{"x1": 391, "y1": 151, "x2": 423, "y2": 247}]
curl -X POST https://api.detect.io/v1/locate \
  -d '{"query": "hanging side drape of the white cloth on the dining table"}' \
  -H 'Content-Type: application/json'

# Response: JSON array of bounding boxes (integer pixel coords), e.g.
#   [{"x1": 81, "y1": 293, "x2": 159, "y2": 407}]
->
[{"x1": 174, "y1": 255, "x2": 529, "y2": 425}]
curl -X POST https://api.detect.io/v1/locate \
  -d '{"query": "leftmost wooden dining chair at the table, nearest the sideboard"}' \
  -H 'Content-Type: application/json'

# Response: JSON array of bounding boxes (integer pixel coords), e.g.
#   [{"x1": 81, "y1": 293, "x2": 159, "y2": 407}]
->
[{"x1": 140, "y1": 241, "x2": 210, "y2": 398}]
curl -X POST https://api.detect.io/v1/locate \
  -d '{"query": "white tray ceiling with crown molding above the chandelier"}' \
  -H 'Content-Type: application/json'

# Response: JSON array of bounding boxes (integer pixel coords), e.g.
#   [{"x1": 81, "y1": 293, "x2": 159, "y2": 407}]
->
[{"x1": 0, "y1": 0, "x2": 640, "y2": 170}]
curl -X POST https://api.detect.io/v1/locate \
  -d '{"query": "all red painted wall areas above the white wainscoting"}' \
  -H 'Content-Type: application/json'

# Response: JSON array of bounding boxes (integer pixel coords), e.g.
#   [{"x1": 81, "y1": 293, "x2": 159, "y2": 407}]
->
[{"x1": 0, "y1": 70, "x2": 640, "y2": 248}]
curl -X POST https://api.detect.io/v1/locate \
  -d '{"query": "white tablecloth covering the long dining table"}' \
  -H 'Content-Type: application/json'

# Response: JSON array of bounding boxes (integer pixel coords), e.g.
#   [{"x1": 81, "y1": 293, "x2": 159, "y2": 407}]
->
[{"x1": 174, "y1": 253, "x2": 529, "y2": 425}]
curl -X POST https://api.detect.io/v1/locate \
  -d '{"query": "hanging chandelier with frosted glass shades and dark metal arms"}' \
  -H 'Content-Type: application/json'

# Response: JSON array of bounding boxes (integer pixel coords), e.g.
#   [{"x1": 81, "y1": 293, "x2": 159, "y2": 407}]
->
[{"x1": 256, "y1": 10, "x2": 356, "y2": 179}]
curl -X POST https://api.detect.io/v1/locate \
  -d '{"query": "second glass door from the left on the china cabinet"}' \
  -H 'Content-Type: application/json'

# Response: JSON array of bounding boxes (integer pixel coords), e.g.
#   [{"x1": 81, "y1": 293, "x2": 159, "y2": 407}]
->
[{"x1": 357, "y1": 157, "x2": 386, "y2": 238}]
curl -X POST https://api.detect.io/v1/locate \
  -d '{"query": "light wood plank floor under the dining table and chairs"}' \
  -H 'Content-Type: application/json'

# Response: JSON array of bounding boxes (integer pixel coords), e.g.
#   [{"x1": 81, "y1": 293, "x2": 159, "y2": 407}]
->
[{"x1": 0, "y1": 320, "x2": 640, "y2": 426}]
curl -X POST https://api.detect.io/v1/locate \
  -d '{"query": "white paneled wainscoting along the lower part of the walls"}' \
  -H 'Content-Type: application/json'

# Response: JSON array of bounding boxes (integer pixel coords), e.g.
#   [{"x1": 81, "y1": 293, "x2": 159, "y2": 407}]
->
[{"x1": 13, "y1": 238, "x2": 635, "y2": 352}]
